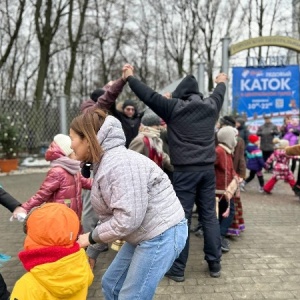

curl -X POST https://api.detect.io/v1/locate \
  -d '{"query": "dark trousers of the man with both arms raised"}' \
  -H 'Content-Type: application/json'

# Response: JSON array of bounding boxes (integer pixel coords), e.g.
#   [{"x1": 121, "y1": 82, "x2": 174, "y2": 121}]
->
[{"x1": 169, "y1": 168, "x2": 222, "y2": 276}]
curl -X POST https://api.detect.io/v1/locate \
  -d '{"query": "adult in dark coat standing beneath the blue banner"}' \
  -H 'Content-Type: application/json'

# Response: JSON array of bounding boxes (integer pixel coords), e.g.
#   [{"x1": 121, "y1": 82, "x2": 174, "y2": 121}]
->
[{"x1": 256, "y1": 115, "x2": 279, "y2": 162}]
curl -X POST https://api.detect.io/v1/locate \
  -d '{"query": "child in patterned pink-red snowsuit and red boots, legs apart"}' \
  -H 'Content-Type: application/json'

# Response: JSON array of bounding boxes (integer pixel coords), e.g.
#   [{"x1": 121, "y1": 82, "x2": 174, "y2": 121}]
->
[{"x1": 264, "y1": 138, "x2": 296, "y2": 194}]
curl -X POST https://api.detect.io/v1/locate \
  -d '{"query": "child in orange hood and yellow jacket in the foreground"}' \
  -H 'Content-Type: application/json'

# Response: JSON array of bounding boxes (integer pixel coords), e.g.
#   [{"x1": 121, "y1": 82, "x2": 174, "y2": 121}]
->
[{"x1": 11, "y1": 203, "x2": 93, "y2": 300}]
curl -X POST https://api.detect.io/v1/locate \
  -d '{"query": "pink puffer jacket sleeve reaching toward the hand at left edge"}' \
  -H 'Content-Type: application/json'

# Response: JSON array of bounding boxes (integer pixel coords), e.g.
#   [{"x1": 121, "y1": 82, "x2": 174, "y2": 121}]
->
[{"x1": 22, "y1": 168, "x2": 61, "y2": 213}]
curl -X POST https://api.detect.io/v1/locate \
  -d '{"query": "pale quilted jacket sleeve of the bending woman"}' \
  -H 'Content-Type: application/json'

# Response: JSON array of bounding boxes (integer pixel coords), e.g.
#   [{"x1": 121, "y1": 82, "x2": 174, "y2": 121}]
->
[{"x1": 92, "y1": 162, "x2": 149, "y2": 243}]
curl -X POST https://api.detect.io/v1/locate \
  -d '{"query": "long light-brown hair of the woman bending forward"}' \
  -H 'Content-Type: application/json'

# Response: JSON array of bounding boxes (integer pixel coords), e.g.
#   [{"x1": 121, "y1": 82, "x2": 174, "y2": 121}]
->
[{"x1": 70, "y1": 109, "x2": 107, "y2": 162}]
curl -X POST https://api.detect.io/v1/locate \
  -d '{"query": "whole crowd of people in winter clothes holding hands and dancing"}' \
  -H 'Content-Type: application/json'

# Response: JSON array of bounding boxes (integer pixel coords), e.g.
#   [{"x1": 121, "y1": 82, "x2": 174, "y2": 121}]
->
[{"x1": 0, "y1": 64, "x2": 300, "y2": 300}]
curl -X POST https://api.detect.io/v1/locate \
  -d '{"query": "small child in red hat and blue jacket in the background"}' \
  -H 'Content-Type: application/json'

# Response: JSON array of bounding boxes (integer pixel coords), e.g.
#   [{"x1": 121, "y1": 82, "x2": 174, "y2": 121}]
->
[{"x1": 241, "y1": 134, "x2": 265, "y2": 193}]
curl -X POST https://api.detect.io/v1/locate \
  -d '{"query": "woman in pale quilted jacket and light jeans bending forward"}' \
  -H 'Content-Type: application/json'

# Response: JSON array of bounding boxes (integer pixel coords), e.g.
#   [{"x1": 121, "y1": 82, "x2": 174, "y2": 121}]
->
[{"x1": 70, "y1": 109, "x2": 188, "y2": 300}]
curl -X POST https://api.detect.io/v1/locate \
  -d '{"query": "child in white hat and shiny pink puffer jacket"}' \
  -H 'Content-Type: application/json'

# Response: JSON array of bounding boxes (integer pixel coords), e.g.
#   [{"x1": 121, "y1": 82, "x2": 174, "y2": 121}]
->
[{"x1": 22, "y1": 134, "x2": 92, "y2": 220}]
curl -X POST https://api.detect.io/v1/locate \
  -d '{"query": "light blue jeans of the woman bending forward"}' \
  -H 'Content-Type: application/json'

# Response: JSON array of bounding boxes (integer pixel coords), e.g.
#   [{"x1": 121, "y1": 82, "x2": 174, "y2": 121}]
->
[{"x1": 102, "y1": 219, "x2": 188, "y2": 300}]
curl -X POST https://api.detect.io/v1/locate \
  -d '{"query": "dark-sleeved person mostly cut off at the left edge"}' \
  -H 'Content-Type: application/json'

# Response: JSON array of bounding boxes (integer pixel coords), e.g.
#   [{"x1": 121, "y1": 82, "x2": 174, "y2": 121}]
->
[{"x1": 0, "y1": 186, "x2": 26, "y2": 300}]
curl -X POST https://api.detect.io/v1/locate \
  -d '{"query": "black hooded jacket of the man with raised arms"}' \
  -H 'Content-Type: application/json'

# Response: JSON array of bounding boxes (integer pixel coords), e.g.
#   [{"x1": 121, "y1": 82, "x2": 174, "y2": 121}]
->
[{"x1": 128, "y1": 75, "x2": 226, "y2": 171}]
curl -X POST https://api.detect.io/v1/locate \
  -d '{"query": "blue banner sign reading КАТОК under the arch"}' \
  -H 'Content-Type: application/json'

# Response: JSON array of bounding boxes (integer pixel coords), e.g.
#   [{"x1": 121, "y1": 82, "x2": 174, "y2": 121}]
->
[{"x1": 232, "y1": 65, "x2": 299, "y2": 121}]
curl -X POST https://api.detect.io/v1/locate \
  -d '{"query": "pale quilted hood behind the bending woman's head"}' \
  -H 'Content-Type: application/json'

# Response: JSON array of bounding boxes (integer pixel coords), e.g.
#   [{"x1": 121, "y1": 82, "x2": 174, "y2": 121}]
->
[{"x1": 97, "y1": 116, "x2": 126, "y2": 151}]
